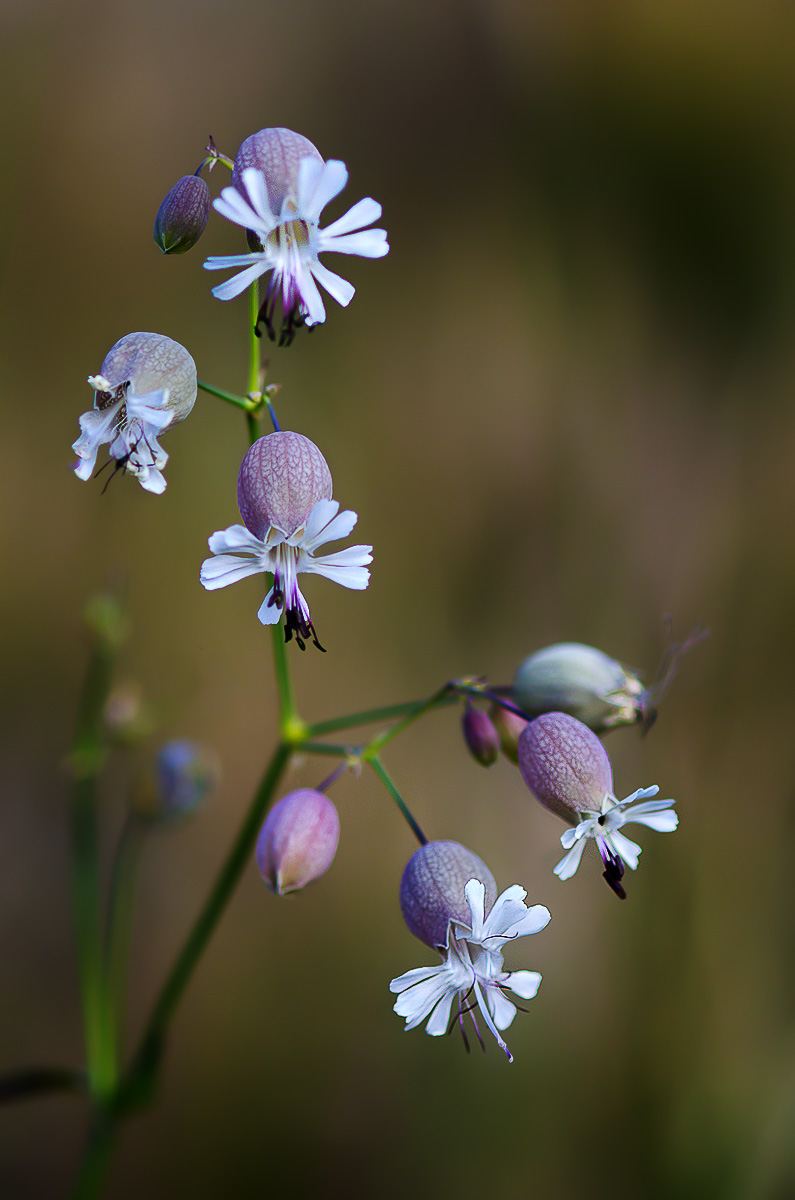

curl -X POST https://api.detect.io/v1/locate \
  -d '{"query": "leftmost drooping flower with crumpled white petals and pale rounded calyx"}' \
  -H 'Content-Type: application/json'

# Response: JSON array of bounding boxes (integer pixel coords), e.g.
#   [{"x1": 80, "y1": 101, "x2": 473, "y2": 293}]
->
[{"x1": 72, "y1": 334, "x2": 196, "y2": 494}]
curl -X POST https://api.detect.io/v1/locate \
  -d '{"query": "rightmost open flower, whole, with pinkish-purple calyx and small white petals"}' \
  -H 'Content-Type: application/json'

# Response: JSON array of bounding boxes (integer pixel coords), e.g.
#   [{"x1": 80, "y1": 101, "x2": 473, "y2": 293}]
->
[{"x1": 519, "y1": 713, "x2": 677, "y2": 900}]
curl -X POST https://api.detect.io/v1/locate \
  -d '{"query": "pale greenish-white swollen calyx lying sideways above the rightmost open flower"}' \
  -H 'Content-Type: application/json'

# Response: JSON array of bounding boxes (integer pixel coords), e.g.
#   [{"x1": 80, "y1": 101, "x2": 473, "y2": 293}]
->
[{"x1": 514, "y1": 642, "x2": 645, "y2": 733}]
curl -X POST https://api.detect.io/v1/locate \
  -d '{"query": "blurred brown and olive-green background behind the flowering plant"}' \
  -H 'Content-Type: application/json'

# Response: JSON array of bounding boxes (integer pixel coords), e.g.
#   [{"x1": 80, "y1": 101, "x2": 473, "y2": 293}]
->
[{"x1": 0, "y1": 0, "x2": 795, "y2": 1200}]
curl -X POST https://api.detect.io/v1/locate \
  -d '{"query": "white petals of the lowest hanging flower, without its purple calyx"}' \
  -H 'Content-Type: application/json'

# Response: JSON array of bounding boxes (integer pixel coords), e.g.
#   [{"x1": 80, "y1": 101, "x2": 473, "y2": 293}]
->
[{"x1": 389, "y1": 880, "x2": 550, "y2": 1062}]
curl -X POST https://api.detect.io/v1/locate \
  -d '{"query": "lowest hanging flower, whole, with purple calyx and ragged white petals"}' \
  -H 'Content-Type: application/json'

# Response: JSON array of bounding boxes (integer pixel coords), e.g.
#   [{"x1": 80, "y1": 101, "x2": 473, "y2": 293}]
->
[{"x1": 389, "y1": 841, "x2": 550, "y2": 1062}]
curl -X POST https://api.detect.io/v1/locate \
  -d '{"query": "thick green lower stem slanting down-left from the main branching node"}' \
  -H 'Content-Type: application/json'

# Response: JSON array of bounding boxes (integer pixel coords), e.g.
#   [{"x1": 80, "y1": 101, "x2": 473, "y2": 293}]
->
[{"x1": 121, "y1": 742, "x2": 292, "y2": 1104}]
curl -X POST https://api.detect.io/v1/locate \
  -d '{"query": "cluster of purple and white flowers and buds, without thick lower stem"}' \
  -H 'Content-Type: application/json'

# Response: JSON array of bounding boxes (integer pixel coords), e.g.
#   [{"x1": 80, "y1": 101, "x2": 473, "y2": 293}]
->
[{"x1": 73, "y1": 121, "x2": 703, "y2": 1080}]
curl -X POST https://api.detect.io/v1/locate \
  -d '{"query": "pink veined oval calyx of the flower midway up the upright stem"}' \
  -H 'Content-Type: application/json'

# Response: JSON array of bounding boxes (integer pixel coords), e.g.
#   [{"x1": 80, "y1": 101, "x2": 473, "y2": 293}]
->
[{"x1": 238, "y1": 432, "x2": 331, "y2": 539}]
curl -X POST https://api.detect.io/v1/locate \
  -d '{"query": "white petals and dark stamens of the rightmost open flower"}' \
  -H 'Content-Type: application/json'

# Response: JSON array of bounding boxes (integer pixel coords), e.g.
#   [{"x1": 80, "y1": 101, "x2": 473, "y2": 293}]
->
[{"x1": 555, "y1": 787, "x2": 679, "y2": 899}]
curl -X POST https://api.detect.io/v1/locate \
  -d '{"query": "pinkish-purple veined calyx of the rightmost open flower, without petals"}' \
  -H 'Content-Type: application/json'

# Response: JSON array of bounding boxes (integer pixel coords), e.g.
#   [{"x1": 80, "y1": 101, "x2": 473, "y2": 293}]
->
[{"x1": 519, "y1": 713, "x2": 612, "y2": 824}]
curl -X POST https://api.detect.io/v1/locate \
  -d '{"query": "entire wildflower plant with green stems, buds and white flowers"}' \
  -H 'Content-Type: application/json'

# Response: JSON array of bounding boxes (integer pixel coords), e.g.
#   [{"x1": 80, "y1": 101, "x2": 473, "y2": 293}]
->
[{"x1": 4, "y1": 121, "x2": 698, "y2": 1198}]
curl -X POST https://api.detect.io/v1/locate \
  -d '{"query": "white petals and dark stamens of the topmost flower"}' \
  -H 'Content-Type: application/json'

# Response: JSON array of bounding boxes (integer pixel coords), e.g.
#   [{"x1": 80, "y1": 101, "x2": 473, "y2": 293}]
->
[{"x1": 204, "y1": 155, "x2": 389, "y2": 344}]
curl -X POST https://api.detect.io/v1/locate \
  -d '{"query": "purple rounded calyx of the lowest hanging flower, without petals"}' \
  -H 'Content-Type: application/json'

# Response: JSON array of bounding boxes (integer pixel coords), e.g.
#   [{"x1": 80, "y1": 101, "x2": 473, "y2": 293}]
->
[{"x1": 400, "y1": 841, "x2": 497, "y2": 947}]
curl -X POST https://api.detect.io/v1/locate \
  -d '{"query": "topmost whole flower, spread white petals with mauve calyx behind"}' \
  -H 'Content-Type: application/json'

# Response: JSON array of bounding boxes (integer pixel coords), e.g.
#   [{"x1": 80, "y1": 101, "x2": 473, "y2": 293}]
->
[{"x1": 204, "y1": 128, "x2": 389, "y2": 346}]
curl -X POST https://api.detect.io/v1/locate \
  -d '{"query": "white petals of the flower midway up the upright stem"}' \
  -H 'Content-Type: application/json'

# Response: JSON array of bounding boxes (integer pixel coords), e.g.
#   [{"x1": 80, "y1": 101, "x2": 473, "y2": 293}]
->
[{"x1": 201, "y1": 499, "x2": 372, "y2": 649}]
